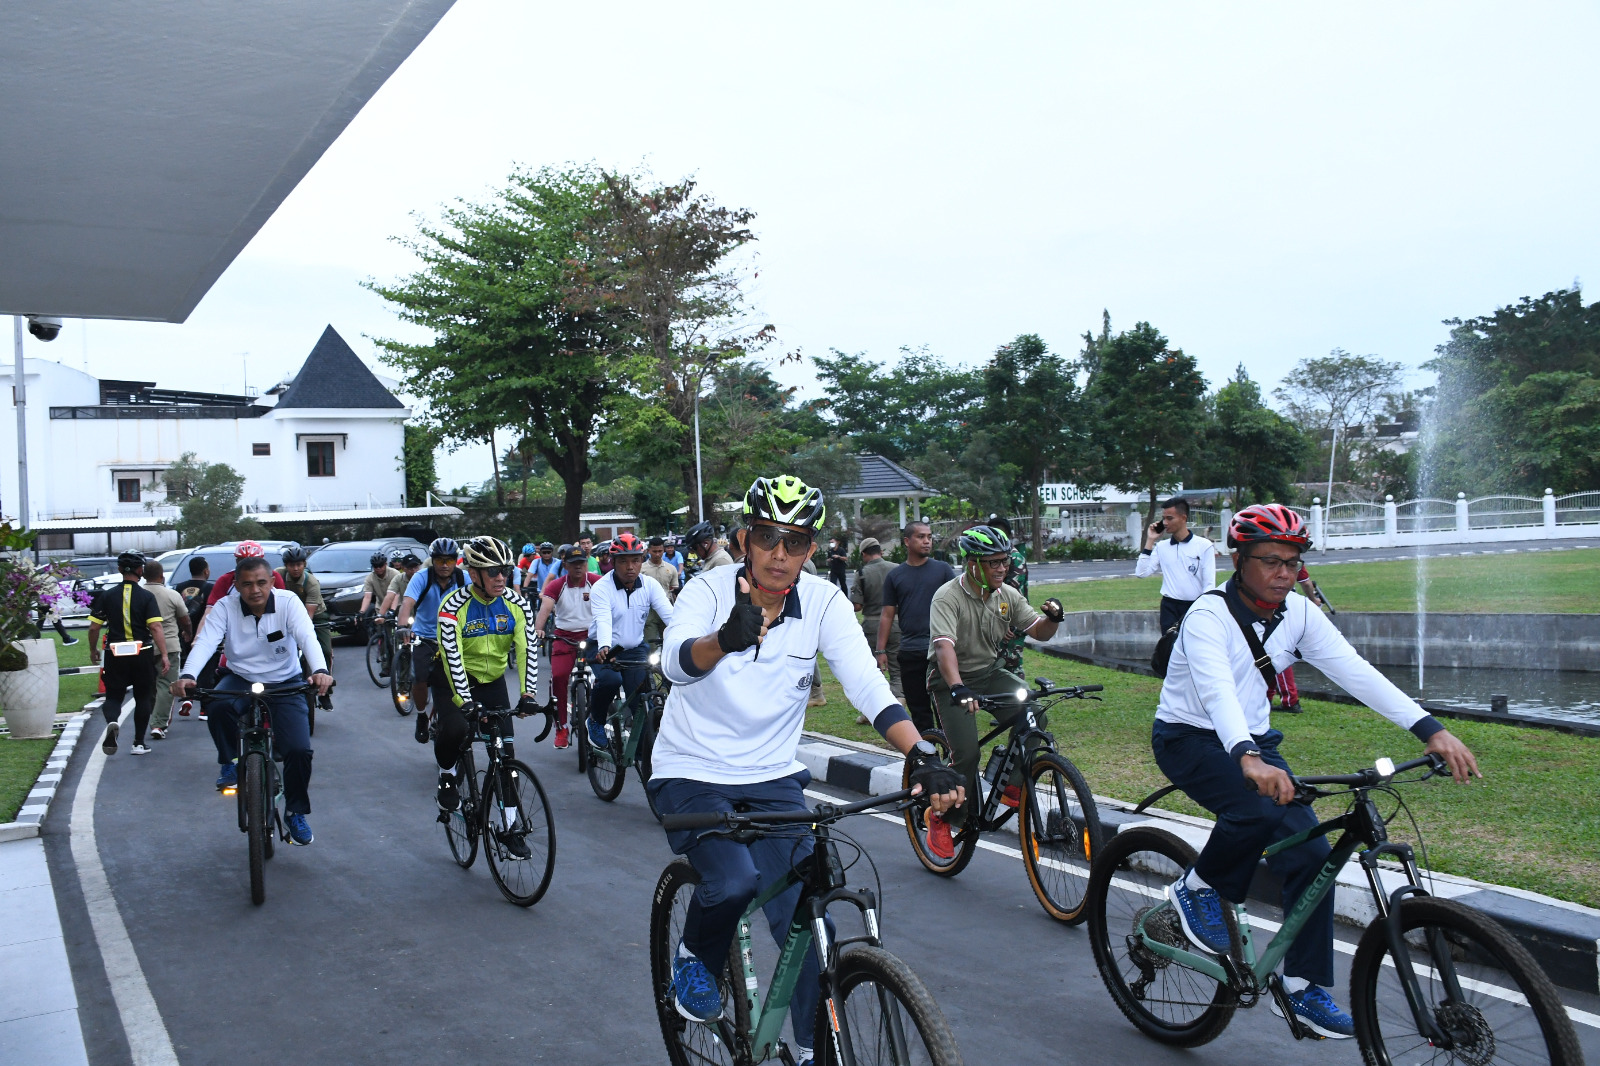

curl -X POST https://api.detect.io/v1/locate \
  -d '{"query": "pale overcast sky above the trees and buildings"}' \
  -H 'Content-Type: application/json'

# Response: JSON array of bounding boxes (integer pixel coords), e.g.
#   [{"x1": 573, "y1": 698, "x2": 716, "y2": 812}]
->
[{"x1": 29, "y1": 0, "x2": 1600, "y2": 485}]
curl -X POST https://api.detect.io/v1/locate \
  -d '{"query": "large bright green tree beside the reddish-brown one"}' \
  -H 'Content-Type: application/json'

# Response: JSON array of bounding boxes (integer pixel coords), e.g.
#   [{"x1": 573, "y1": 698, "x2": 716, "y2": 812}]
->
[{"x1": 368, "y1": 168, "x2": 634, "y2": 538}]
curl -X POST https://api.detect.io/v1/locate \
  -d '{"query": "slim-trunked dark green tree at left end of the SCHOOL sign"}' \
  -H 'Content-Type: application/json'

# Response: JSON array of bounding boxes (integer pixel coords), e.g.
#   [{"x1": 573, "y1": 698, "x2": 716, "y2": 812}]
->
[{"x1": 982, "y1": 333, "x2": 1086, "y2": 555}]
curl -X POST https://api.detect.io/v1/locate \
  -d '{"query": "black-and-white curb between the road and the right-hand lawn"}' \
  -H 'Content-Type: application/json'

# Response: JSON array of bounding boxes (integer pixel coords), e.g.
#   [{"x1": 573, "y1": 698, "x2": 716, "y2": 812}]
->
[{"x1": 797, "y1": 731, "x2": 1600, "y2": 994}]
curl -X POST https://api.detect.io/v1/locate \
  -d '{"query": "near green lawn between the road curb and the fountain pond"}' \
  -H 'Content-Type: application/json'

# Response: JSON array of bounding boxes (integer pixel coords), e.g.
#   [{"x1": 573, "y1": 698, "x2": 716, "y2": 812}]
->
[{"x1": 806, "y1": 640, "x2": 1600, "y2": 906}]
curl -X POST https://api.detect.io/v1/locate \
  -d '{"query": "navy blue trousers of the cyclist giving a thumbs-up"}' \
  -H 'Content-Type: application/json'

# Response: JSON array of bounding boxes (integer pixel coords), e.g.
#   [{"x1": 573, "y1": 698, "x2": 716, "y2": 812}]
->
[{"x1": 648, "y1": 770, "x2": 834, "y2": 1047}]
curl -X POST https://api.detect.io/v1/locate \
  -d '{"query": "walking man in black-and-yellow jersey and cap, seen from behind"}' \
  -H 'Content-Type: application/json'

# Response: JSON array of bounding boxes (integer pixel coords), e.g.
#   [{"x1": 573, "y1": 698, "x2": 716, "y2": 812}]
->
[{"x1": 90, "y1": 552, "x2": 178, "y2": 755}]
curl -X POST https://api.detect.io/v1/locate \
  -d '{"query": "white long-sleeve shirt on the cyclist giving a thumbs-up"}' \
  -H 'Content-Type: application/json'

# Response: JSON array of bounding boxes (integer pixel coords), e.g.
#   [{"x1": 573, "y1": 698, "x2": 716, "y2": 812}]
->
[{"x1": 650, "y1": 567, "x2": 906, "y2": 784}]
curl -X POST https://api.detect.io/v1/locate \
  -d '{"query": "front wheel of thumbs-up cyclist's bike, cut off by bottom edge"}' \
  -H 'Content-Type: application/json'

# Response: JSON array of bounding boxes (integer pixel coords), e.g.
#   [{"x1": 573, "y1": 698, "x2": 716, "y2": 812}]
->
[{"x1": 813, "y1": 948, "x2": 962, "y2": 1066}]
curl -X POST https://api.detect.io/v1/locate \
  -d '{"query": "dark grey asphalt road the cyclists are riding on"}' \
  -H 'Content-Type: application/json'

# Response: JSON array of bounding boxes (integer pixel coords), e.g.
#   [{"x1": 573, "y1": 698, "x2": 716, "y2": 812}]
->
[{"x1": 45, "y1": 647, "x2": 1600, "y2": 1066}]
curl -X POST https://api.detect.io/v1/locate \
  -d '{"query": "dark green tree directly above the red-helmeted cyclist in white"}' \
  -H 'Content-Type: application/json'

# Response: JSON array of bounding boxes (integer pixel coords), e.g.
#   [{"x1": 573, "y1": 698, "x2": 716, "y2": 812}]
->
[{"x1": 1194, "y1": 363, "x2": 1314, "y2": 507}]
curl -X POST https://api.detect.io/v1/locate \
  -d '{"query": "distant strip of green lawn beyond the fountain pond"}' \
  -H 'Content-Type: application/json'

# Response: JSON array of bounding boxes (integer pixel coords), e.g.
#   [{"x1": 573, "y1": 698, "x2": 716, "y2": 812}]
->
[{"x1": 1030, "y1": 549, "x2": 1600, "y2": 615}]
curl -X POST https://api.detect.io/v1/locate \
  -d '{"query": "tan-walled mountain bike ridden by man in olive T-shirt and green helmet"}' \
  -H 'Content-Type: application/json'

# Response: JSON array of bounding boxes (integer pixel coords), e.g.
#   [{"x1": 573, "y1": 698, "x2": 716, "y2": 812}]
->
[{"x1": 901, "y1": 677, "x2": 1104, "y2": 925}]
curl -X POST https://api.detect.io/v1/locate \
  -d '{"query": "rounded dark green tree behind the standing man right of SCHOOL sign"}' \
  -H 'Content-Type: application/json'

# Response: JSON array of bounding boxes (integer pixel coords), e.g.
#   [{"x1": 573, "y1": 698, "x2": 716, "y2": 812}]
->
[{"x1": 1083, "y1": 317, "x2": 1205, "y2": 522}]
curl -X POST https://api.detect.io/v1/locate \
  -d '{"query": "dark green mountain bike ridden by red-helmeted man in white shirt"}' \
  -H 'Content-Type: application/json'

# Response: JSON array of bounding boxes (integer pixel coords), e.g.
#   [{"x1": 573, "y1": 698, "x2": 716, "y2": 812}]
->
[{"x1": 1088, "y1": 755, "x2": 1582, "y2": 1066}]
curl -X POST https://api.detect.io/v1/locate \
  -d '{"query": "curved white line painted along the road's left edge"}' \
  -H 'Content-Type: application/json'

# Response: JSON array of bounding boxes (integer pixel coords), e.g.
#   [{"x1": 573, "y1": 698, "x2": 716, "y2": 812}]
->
[{"x1": 72, "y1": 698, "x2": 178, "y2": 1066}]
